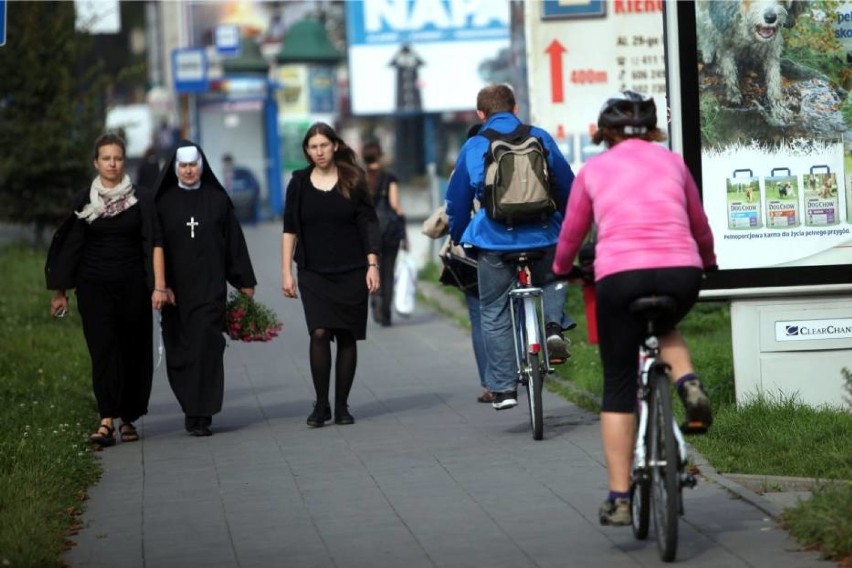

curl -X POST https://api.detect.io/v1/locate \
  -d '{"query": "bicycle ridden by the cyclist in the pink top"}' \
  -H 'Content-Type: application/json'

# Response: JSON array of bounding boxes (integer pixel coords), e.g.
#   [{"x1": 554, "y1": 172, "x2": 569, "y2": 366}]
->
[{"x1": 630, "y1": 296, "x2": 697, "y2": 562}]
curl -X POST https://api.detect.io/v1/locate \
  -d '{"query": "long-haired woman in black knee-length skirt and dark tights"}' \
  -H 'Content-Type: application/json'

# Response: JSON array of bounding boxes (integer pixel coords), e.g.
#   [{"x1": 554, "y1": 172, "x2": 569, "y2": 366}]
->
[{"x1": 281, "y1": 123, "x2": 380, "y2": 427}]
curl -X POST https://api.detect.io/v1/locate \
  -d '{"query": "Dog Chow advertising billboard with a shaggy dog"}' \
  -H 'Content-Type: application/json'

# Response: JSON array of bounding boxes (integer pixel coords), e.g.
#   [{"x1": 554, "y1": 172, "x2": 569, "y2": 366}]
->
[{"x1": 666, "y1": 0, "x2": 852, "y2": 295}]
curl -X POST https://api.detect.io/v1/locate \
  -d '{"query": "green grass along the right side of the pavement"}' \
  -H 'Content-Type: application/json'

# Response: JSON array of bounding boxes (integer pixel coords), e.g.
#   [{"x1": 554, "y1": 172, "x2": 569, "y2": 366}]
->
[{"x1": 423, "y1": 264, "x2": 852, "y2": 559}]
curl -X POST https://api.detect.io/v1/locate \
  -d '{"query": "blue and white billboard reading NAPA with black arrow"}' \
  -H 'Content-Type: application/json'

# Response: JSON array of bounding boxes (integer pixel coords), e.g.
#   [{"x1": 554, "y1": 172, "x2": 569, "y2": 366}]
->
[{"x1": 346, "y1": 0, "x2": 510, "y2": 115}]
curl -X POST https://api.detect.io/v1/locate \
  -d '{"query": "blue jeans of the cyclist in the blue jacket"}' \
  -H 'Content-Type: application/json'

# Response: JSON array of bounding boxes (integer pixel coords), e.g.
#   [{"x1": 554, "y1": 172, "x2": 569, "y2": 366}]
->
[{"x1": 477, "y1": 247, "x2": 577, "y2": 392}]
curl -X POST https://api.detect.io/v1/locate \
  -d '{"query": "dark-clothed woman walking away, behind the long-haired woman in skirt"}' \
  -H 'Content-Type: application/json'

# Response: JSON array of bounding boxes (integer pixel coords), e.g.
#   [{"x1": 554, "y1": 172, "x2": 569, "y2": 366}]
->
[{"x1": 361, "y1": 141, "x2": 408, "y2": 327}]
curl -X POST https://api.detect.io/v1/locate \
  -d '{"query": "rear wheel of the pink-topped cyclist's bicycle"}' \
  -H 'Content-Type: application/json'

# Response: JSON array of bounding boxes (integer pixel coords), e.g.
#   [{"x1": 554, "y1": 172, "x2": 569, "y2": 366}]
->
[{"x1": 648, "y1": 367, "x2": 680, "y2": 562}]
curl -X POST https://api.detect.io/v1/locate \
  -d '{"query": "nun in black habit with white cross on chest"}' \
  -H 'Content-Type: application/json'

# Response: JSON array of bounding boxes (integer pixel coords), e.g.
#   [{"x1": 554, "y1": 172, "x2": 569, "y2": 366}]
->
[{"x1": 153, "y1": 140, "x2": 257, "y2": 436}]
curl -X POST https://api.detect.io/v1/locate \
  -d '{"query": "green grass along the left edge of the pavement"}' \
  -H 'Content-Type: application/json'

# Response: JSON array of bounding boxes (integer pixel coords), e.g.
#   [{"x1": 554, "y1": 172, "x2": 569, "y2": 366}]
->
[{"x1": 0, "y1": 248, "x2": 100, "y2": 566}]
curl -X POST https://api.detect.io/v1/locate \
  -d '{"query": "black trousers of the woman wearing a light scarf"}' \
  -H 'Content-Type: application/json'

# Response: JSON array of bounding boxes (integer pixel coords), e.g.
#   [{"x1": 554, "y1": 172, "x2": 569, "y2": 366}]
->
[{"x1": 77, "y1": 275, "x2": 154, "y2": 422}]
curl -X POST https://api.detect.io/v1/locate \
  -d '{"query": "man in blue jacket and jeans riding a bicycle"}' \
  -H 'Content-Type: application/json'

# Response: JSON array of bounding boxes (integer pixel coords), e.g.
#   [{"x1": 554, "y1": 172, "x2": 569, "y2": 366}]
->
[{"x1": 446, "y1": 85, "x2": 577, "y2": 410}]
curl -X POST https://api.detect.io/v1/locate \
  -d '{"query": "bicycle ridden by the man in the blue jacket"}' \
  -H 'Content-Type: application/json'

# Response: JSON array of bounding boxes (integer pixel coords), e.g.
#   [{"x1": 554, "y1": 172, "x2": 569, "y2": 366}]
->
[{"x1": 502, "y1": 250, "x2": 553, "y2": 440}]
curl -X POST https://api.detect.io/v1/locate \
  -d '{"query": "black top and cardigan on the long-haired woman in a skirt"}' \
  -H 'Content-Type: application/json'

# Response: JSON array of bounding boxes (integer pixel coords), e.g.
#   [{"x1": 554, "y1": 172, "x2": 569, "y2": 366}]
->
[{"x1": 284, "y1": 166, "x2": 381, "y2": 273}]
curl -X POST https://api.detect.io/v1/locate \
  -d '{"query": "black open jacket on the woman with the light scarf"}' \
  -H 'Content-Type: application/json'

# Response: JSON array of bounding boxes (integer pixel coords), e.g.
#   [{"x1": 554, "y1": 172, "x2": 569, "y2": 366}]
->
[{"x1": 44, "y1": 185, "x2": 154, "y2": 290}]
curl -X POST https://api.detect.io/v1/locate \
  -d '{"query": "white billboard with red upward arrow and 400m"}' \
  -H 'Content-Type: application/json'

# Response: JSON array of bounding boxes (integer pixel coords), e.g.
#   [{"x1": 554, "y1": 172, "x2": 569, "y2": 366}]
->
[{"x1": 524, "y1": 0, "x2": 666, "y2": 169}]
